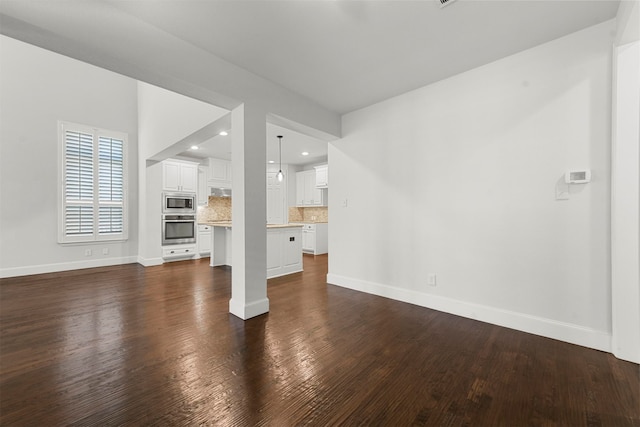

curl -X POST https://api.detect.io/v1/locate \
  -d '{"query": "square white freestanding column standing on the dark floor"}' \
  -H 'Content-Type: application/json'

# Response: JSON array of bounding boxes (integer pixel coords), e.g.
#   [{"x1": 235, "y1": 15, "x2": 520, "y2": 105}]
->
[{"x1": 229, "y1": 103, "x2": 269, "y2": 320}]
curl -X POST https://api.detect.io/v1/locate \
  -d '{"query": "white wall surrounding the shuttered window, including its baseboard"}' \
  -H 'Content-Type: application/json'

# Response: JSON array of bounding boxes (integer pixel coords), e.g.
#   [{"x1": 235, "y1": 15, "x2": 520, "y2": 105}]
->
[{"x1": 0, "y1": 36, "x2": 138, "y2": 276}]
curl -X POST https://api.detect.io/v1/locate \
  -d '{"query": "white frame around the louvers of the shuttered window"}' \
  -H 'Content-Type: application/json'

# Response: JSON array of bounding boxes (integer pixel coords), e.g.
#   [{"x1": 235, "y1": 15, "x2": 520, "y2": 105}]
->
[{"x1": 57, "y1": 120, "x2": 129, "y2": 245}]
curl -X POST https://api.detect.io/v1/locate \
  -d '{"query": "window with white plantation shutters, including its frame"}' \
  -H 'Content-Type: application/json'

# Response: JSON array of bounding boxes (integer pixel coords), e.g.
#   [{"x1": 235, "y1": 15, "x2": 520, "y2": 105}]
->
[{"x1": 58, "y1": 122, "x2": 127, "y2": 243}]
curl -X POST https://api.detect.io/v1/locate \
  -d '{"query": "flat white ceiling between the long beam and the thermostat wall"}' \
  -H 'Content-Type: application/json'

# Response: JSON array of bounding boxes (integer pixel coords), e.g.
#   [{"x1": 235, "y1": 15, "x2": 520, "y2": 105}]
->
[{"x1": 111, "y1": 0, "x2": 619, "y2": 113}]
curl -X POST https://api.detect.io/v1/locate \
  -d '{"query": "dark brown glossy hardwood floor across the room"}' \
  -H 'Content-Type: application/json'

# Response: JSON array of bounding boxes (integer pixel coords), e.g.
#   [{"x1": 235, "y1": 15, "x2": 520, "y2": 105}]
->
[{"x1": 0, "y1": 256, "x2": 640, "y2": 427}]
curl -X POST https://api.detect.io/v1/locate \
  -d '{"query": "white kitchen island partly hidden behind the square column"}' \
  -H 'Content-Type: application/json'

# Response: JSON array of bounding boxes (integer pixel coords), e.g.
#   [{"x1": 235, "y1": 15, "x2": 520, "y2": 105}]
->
[{"x1": 200, "y1": 221, "x2": 302, "y2": 279}]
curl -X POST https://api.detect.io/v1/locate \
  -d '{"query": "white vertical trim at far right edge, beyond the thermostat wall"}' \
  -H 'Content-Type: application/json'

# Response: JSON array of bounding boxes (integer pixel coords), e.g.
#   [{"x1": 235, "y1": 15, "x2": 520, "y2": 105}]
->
[{"x1": 611, "y1": 42, "x2": 640, "y2": 363}]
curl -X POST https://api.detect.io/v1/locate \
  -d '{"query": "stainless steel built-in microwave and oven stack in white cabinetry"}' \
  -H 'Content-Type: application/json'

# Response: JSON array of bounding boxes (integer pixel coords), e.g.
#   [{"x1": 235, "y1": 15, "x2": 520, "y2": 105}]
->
[{"x1": 162, "y1": 193, "x2": 197, "y2": 246}]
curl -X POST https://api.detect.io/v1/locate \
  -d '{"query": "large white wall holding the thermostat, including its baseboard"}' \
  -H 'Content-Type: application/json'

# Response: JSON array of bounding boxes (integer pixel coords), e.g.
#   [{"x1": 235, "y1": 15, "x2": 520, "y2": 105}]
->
[{"x1": 328, "y1": 21, "x2": 615, "y2": 350}]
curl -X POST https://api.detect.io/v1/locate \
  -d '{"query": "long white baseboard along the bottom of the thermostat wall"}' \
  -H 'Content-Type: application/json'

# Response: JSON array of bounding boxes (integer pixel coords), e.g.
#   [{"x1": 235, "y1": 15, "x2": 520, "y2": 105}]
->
[{"x1": 327, "y1": 273, "x2": 611, "y2": 353}]
